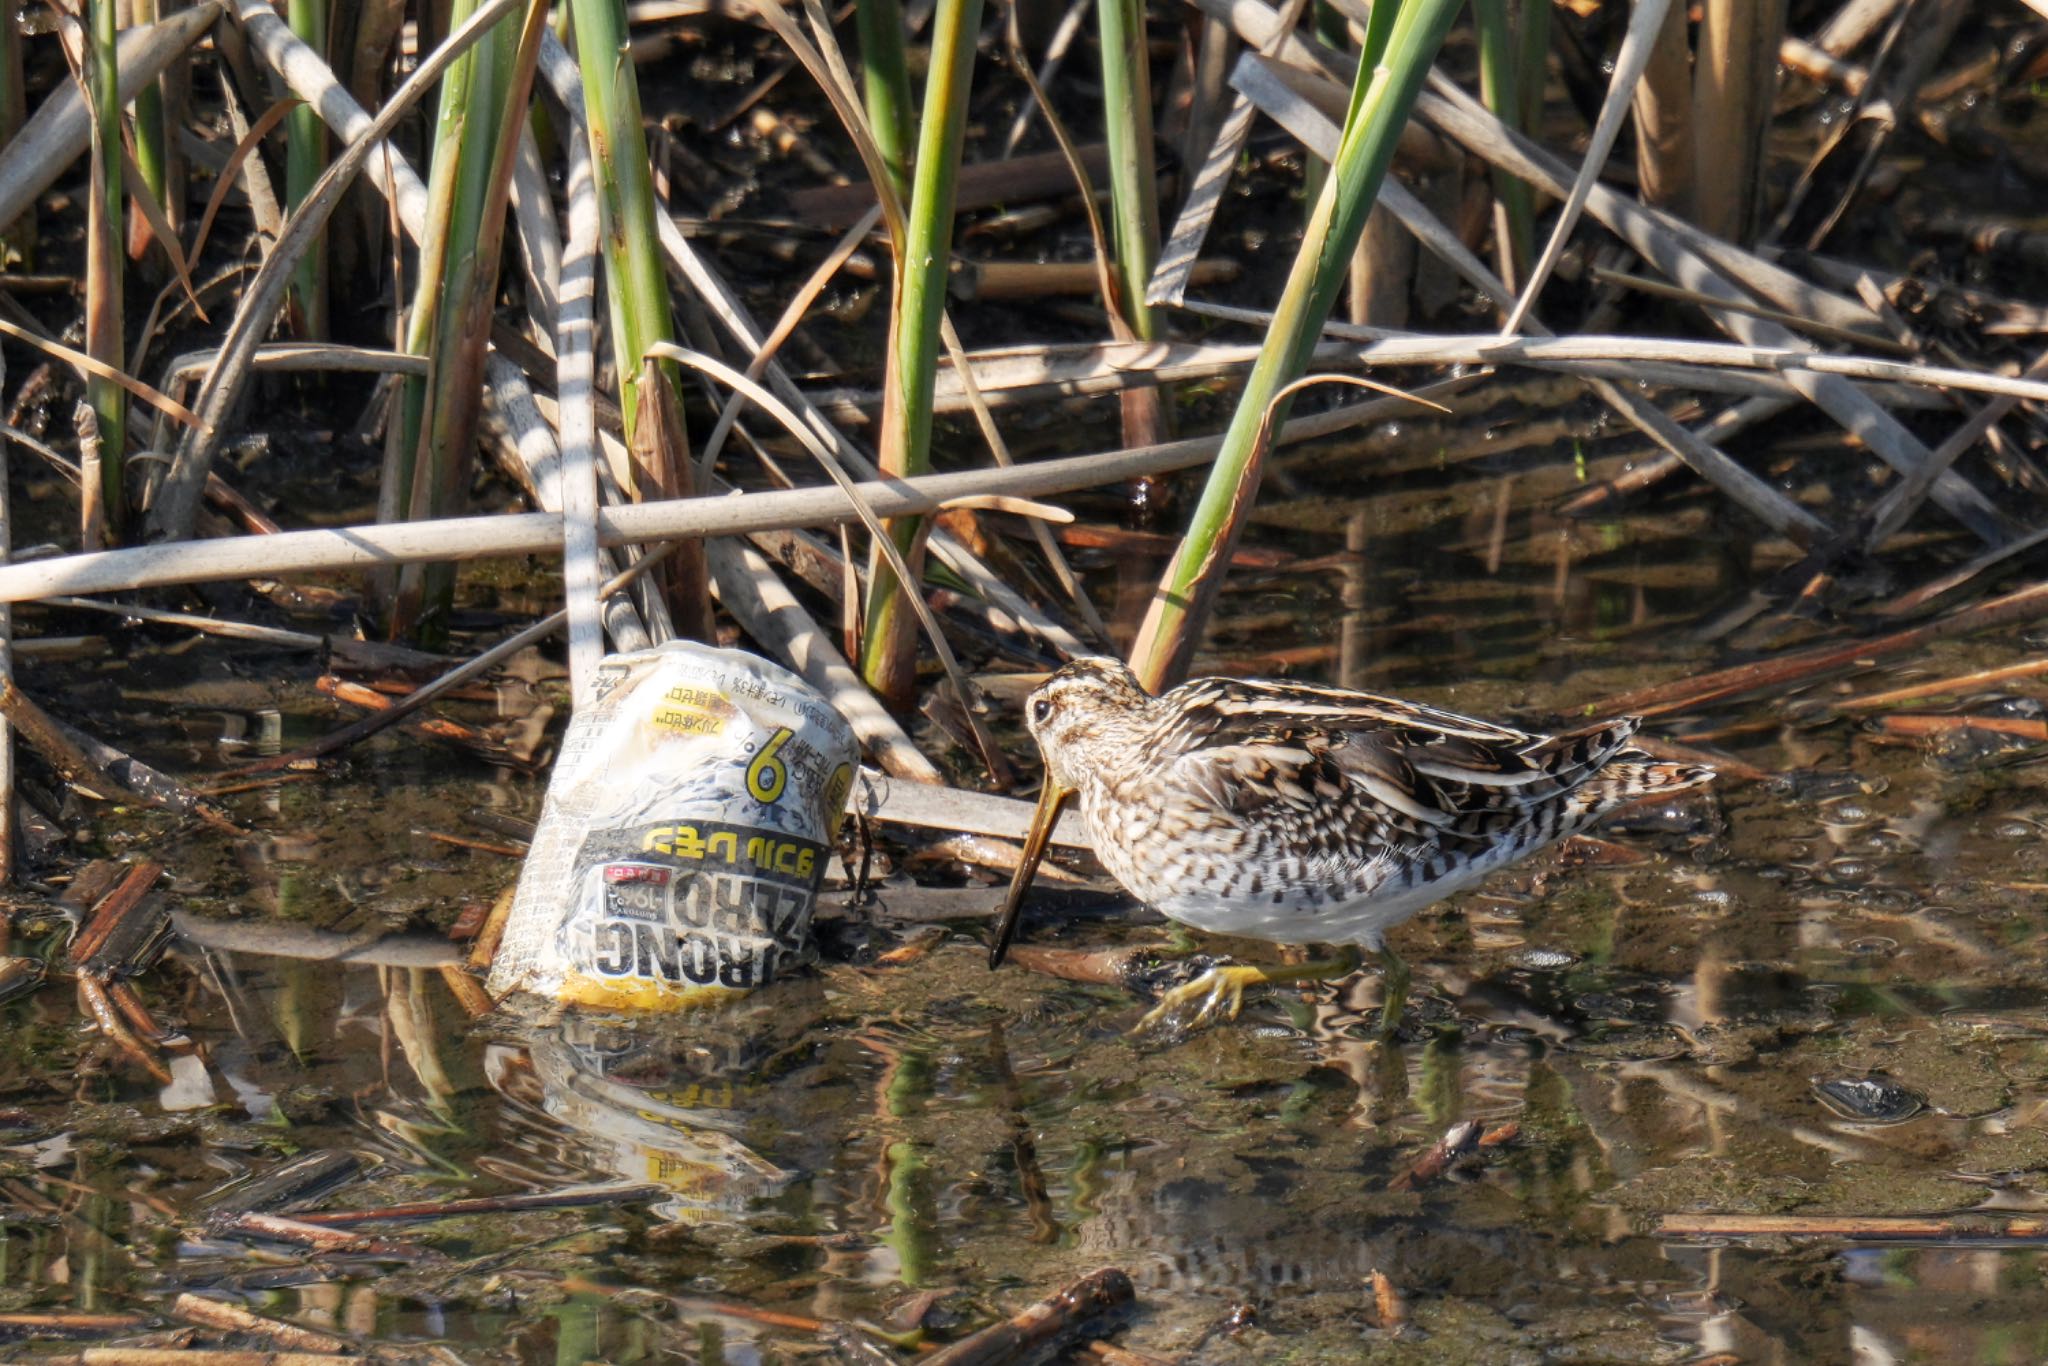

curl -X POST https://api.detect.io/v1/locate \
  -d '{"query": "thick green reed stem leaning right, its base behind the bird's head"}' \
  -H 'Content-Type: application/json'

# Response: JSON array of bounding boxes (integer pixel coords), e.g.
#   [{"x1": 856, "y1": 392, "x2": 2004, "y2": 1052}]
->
[{"x1": 1130, "y1": 0, "x2": 1458, "y2": 688}]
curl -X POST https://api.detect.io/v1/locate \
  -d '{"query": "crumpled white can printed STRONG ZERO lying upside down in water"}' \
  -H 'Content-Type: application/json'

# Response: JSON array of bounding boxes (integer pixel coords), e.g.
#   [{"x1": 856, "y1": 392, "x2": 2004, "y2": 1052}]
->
[{"x1": 489, "y1": 641, "x2": 858, "y2": 1010}]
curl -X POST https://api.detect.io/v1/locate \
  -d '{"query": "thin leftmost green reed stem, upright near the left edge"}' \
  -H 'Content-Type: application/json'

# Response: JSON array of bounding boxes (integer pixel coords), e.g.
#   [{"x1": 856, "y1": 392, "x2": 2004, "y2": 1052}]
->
[{"x1": 80, "y1": 0, "x2": 127, "y2": 549}]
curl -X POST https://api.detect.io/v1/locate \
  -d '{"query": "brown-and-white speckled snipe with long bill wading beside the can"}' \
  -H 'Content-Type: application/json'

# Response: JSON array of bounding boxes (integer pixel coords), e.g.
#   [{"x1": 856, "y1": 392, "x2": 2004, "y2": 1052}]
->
[{"x1": 989, "y1": 657, "x2": 1714, "y2": 1034}]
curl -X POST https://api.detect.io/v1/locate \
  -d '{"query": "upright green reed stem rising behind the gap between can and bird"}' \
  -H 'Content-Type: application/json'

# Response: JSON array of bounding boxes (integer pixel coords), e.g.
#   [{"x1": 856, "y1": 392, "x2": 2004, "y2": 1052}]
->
[{"x1": 860, "y1": 0, "x2": 981, "y2": 705}]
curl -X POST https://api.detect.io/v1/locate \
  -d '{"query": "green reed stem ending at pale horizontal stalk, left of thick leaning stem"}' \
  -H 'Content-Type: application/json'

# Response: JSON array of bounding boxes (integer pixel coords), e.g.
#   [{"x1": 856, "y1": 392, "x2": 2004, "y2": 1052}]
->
[{"x1": 1096, "y1": 0, "x2": 1159, "y2": 342}]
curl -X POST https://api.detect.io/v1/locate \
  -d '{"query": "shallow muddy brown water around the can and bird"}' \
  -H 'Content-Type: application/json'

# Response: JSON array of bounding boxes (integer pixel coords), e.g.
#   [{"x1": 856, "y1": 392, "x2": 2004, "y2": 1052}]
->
[{"x1": 0, "y1": 397, "x2": 2048, "y2": 1364}]
